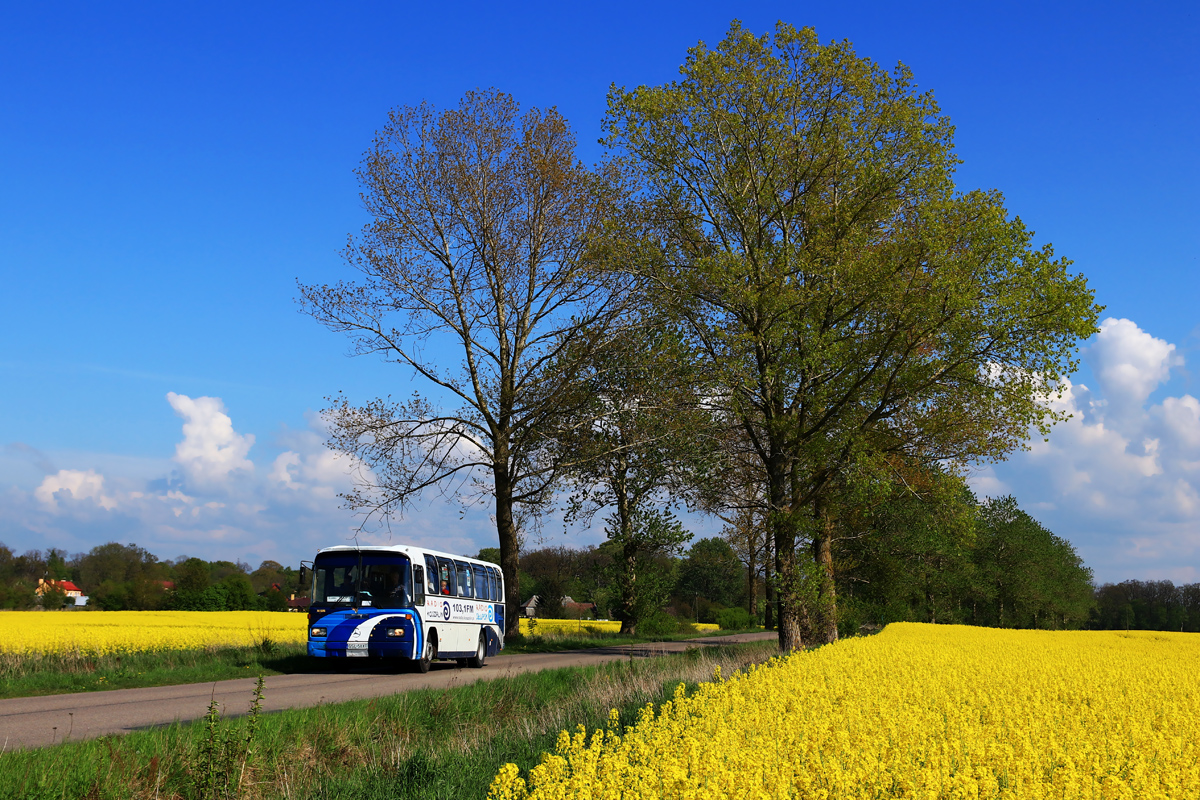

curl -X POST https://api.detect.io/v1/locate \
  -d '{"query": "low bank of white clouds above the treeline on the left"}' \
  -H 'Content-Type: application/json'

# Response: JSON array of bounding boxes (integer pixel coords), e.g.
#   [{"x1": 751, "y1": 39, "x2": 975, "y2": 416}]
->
[{"x1": 0, "y1": 392, "x2": 506, "y2": 564}]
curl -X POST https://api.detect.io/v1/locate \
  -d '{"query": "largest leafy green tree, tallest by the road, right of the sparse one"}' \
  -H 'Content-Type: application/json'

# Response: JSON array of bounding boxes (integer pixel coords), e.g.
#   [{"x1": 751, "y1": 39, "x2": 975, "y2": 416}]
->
[{"x1": 606, "y1": 23, "x2": 1098, "y2": 650}]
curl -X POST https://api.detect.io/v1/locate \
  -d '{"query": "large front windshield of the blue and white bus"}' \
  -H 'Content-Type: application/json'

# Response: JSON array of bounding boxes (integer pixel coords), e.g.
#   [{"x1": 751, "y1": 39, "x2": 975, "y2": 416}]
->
[{"x1": 312, "y1": 552, "x2": 413, "y2": 608}]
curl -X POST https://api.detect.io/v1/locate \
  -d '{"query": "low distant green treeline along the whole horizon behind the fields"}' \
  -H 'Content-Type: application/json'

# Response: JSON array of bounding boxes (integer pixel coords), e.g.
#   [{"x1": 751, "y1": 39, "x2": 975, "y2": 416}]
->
[{"x1": 0, "y1": 485, "x2": 1200, "y2": 636}]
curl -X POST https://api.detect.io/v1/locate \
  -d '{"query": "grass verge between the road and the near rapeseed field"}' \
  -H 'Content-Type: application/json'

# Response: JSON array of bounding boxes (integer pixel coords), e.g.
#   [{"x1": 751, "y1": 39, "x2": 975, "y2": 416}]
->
[{"x1": 0, "y1": 642, "x2": 776, "y2": 800}]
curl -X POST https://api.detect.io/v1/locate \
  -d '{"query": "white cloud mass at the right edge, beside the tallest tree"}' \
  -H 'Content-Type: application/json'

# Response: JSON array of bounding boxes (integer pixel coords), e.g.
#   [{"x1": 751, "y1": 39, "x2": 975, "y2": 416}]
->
[{"x1": 977, "y1": 319, "x2": 1200, "y2": 581}]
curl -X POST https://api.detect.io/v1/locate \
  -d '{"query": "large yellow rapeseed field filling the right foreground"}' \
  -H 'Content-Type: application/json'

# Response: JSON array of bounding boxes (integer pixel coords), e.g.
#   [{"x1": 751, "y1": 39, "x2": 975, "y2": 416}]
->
[{"x1": 488, "y1": 624, "x2": 1200, "y2": 800}]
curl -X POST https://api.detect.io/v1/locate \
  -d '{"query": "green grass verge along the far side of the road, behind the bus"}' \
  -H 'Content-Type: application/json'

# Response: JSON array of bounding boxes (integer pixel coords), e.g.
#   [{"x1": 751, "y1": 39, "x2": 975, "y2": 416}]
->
[{"x1": 0, "y1": 631, "x2": 763, "y2": 698}]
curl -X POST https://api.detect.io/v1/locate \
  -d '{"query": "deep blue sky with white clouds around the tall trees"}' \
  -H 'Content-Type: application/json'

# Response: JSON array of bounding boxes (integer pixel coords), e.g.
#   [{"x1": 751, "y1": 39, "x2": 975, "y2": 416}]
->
[{"x1": 0, "y1": 1, "x2": 1200, "y2": 581}]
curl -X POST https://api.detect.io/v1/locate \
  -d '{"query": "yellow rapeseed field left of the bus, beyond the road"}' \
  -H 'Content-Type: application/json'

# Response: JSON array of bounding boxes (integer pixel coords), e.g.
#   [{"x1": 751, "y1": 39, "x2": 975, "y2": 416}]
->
[{"x1": 0, "y1": 612, "x2": 308, "y2": 655}]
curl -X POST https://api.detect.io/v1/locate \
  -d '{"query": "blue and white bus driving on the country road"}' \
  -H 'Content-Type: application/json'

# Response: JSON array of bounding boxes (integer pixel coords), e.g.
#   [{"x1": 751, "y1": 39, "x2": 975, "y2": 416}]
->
[{"x1": 308, "y1": 545, "x2": 504, "y2": 673}]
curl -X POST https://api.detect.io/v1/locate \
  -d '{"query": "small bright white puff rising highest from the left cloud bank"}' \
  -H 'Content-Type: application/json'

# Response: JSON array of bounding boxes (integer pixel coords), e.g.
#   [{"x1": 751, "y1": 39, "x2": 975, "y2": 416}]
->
[{"x1": 167, "y1": 392, "x2": 254, "y2": 485}]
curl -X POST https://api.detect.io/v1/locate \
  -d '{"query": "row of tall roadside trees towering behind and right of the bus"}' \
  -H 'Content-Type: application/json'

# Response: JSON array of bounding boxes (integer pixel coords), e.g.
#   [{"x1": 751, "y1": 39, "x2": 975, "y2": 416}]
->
[{"x1": 300, "y1": 23, "x2": 1099, "y2": 649}]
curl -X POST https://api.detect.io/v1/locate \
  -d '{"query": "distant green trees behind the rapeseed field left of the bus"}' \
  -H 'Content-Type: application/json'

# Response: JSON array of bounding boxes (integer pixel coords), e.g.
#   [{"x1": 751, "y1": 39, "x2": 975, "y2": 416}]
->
[{"x1": 0, "y1": 542, "x2": 299, "y2": 610}]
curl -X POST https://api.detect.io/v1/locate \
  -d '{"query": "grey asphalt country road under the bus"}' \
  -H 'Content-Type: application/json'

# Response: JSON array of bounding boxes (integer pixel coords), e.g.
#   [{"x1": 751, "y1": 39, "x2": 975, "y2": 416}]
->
[{"x1": 0, "y1": 632, "x2": 776, "y2": 752}]
